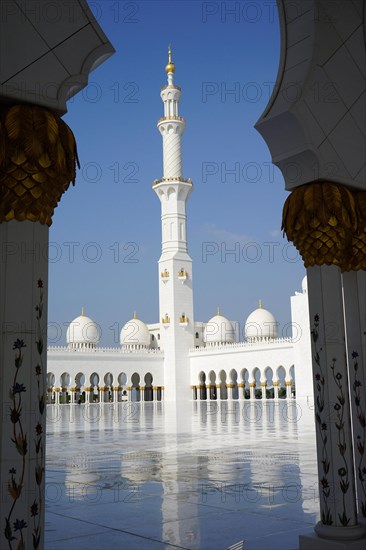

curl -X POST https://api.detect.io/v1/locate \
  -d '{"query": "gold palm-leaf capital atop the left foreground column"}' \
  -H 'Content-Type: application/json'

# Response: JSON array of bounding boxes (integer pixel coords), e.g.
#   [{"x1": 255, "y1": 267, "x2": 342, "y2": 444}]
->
[{"x1": 0, "y1": 105, "x2": 80, "y2": 225}]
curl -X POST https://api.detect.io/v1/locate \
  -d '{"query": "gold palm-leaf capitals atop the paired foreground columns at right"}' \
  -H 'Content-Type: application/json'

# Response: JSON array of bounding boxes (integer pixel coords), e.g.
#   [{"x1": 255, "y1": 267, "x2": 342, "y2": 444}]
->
[{"x1": 282, "y1": 182, "x2": 366, "y2": 271}]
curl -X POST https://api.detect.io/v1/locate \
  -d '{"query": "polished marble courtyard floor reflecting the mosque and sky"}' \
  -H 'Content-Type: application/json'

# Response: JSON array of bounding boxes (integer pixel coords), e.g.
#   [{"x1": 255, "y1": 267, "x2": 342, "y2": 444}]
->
[{"x1": 45, "y1": 400, "x2": 319, "y2": 550}]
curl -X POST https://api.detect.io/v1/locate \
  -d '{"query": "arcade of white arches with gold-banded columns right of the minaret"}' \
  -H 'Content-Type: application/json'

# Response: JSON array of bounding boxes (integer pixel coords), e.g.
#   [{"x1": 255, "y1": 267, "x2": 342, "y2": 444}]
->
[{"x1": 192, "y1": 365, "x2": 296, "y2": 400}]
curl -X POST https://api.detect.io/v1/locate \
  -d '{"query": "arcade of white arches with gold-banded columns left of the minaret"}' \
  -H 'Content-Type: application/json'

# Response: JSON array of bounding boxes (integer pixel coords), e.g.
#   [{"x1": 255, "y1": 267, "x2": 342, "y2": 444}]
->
[{"x1": 47, "y1": 371, "x2": 164, "y2": 404}]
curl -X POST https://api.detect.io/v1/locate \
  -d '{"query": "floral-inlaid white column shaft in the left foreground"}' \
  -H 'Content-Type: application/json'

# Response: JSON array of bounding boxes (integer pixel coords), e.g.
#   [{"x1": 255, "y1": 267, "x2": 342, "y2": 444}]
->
[{"x1": 0, "y1": 220, "x2": 48, "y2": 549}]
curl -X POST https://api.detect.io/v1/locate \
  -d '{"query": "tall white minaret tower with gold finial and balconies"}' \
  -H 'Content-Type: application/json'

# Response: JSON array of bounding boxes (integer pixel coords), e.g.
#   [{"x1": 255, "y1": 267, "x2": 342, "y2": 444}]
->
[{"x1": 153, "y1": 46, "x2": 194, "y2": 401}]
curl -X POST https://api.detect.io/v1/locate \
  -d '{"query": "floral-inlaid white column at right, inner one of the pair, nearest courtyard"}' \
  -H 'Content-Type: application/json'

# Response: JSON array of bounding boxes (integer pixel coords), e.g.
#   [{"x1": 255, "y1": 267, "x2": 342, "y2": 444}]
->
[{"x1": 300, "y1": 266, "x2": 365, "y2": 549}]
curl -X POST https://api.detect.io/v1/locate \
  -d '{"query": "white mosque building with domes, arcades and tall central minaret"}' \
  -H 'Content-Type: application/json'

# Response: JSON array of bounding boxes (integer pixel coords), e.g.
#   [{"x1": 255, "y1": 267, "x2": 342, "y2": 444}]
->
[{"x1": 47, "y1": 49, "x2": 312, "y2": 403}]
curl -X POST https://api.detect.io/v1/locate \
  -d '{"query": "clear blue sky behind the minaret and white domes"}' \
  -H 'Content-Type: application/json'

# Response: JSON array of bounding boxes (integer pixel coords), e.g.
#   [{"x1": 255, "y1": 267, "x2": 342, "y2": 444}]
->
[{"x1": 49, "y1": 0, "x2": 305, "y2": 346}]
